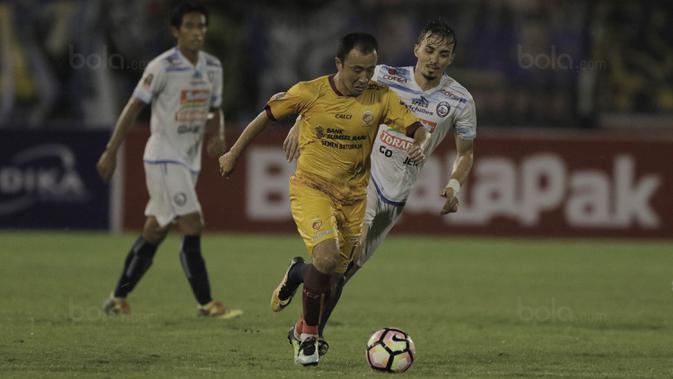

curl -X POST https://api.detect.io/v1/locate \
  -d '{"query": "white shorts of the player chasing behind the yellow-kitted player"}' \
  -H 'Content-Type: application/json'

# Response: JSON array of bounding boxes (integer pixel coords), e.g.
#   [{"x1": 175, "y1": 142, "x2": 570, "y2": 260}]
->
[{"x1": 355, "y1": 179, "x2": 405, "y2": 267}]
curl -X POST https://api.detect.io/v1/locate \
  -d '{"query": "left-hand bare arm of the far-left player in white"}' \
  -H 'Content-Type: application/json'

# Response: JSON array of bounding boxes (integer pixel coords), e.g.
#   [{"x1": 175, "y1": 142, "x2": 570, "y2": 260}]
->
[{"x1": 96, "y1": 97, "x2": 145, "y2": 182}]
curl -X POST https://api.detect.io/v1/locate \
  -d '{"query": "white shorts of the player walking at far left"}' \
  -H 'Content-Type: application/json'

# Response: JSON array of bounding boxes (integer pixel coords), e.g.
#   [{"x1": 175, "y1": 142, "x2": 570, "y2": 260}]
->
[{"x1": 145, "y1": 162, "x2": 203, "y2": 227}]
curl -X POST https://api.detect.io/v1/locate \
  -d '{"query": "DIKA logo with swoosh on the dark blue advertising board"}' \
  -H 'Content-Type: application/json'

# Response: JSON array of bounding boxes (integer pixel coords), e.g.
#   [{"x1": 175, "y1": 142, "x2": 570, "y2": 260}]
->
[{"x1": 0, "y1": 144, "x2": 89, "y2": 216}]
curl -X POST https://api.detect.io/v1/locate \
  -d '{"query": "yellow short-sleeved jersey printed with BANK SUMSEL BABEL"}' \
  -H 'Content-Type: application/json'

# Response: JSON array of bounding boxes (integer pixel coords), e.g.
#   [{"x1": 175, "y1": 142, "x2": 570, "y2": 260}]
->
[{"x1": 266, "y1": 75, "x2": 420, "y2": 203}]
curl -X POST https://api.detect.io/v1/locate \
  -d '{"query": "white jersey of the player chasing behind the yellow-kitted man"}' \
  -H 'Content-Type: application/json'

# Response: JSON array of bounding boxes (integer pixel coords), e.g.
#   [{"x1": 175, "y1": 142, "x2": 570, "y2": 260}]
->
[{"x1": 371, "y1": 65, "x2": 477, "y2": 204}]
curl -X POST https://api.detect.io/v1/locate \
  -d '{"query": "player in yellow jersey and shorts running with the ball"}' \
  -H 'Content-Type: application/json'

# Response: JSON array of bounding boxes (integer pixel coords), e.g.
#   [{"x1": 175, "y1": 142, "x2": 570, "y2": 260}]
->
[{"x1": 219, "y1": 33, "x2": 428, "y2": 366}]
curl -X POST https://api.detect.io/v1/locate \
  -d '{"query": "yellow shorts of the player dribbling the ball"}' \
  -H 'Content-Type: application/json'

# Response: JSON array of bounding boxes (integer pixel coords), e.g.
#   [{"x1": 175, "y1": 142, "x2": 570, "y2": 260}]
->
[{"x1": 290, "y1": 176, "x2": 367, "y2": 274}]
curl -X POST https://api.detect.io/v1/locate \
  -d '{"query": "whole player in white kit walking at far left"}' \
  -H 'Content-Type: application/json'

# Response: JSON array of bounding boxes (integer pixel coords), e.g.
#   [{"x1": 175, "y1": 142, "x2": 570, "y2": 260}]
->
[{"x1": 96, "y1": 3, "x2": 242, "y2": 319}]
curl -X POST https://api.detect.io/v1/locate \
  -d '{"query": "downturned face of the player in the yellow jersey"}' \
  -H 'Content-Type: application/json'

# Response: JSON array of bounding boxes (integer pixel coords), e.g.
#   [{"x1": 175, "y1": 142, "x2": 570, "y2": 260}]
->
[{"x1": 336, "y1": 48, "x2": 378, "y2": 96}]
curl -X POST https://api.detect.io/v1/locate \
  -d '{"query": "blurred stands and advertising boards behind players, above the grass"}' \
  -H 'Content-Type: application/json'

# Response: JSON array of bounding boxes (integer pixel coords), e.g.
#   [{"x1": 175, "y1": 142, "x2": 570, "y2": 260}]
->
[{"x1": 0, "y1": 0, "x2": 673, "y2": 237}]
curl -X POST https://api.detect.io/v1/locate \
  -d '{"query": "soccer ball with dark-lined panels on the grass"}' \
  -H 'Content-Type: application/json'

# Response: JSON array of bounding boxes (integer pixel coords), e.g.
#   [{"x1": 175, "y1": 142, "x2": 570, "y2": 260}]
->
[{"x1": 366, "y1": 328, "x2": 416, "y2": 372}]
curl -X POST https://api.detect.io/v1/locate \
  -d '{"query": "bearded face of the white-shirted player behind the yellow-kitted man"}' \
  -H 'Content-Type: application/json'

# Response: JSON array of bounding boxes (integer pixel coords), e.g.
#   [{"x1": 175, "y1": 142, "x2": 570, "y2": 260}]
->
[{"x1": 414, "y1": 33, "x2": 455, "y2": 81}]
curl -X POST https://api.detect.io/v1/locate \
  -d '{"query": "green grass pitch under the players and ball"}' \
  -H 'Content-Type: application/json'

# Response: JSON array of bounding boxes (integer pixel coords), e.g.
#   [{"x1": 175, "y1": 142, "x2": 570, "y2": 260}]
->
[{"x1": 0, "y1": 232, "x2": 673, "y2": 378}]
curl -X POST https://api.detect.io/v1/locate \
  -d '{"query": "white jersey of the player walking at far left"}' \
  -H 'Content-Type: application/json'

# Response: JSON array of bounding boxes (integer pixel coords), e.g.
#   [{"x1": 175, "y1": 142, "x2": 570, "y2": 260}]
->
[{"x1": 133, "y1": 48, "x2": 222, "y2": 172}]
